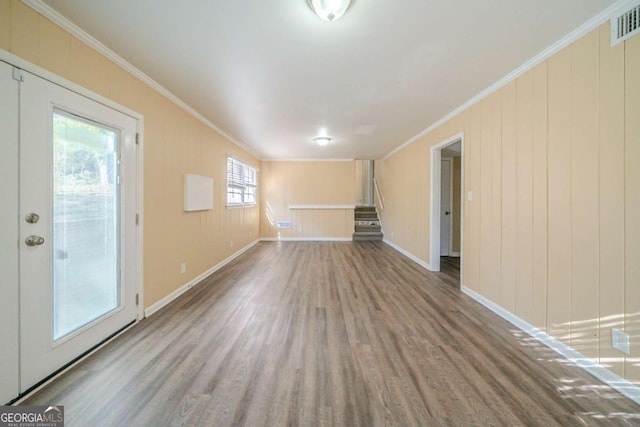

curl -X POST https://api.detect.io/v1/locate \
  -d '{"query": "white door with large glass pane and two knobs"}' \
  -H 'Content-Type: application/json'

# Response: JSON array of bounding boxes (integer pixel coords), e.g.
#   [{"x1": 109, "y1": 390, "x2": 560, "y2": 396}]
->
[{"x1": 19, "y1": 72, "x2": 137, "y2": 392}]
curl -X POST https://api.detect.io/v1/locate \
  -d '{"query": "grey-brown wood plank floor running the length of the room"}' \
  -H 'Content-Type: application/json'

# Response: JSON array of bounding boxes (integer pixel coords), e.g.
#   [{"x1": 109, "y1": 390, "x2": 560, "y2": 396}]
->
[{"x1": 23, "y1": 242, "x2": 640, "y2": 426}]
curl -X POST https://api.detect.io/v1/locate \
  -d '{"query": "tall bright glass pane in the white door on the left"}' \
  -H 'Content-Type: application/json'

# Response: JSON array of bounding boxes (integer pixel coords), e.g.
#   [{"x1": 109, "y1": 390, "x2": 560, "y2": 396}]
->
[{"x1": 53, "y1": 110, "x2": 120, "y2": 340}]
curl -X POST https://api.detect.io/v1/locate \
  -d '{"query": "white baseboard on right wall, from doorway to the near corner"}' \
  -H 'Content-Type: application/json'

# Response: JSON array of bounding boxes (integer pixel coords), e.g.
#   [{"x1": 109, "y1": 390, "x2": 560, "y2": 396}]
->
[{"x1": 460, "y1": 286, "x2": 640, "y2": 404}]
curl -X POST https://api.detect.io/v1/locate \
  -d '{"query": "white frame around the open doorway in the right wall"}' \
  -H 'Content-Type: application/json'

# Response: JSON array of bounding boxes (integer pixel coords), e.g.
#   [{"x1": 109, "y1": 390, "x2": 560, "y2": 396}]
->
[{"x1": 429, "y1": 132, "x2": 464, "y2": 280}]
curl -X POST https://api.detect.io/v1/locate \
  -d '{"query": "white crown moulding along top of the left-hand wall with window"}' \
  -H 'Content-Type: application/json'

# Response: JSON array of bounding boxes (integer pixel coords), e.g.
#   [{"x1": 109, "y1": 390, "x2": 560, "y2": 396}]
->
[{"x1": 21, "y1": 0, "x2": 260, "y2": 159}]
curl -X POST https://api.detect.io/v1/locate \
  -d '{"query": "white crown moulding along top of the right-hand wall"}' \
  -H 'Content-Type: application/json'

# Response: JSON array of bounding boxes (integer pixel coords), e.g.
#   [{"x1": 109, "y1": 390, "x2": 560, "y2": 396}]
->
[{"x1": 382, "y1": 0, "x2": 628, "y2": 160}]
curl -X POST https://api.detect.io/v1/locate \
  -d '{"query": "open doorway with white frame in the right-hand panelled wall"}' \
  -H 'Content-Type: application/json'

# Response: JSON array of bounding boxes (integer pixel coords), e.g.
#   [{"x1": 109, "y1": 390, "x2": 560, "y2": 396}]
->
[{"x1": 430, "y1": 133, "x2": 464, "y2": 286}]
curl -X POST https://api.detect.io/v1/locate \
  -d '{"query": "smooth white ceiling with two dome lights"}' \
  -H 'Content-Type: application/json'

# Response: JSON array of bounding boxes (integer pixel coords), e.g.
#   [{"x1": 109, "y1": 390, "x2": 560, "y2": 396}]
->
[{"x1": 38, "y1": 0, "x2": 614, "y2": 159}]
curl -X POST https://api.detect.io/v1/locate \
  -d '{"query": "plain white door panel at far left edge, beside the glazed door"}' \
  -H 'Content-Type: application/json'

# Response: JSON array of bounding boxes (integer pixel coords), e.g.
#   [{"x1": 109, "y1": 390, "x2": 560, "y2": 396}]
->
[{"x1": 0, "y1": 62, "x2": 19, "y2": 405}]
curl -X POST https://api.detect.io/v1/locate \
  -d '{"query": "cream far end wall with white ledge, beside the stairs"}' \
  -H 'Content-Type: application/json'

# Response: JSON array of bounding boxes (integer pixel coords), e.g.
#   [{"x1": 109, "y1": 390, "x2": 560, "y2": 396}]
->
[{"x1": 260, "y1": 161, "x2": 356, "y2": 239}]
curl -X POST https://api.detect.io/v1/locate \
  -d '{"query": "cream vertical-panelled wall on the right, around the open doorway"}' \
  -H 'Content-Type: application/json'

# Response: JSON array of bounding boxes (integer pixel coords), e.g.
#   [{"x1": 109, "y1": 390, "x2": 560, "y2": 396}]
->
[{"x1": 376, "y1": 23, "x2": 640, "y2": 384}]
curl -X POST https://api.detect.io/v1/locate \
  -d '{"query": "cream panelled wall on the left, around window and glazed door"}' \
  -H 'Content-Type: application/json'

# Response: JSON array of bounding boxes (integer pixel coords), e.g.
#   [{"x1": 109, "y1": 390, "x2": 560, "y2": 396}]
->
[{"x1": 0, "y1": 0, "x2": 260, "y2": 307}]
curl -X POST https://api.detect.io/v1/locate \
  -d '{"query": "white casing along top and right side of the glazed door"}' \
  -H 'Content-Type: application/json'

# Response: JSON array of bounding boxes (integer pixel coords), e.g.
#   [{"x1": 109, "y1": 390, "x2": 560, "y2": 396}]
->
[{"x1": 0, "y1": 49, "x2": 144, "y2": 320}]
